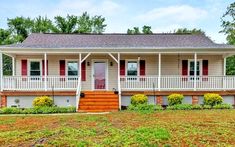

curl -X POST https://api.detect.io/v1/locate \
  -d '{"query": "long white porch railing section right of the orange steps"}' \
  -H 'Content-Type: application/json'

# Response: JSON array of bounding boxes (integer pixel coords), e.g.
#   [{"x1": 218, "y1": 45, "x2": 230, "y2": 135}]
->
[{"x1": 120, "y1": 75, "x2": 235, "y2": 91}]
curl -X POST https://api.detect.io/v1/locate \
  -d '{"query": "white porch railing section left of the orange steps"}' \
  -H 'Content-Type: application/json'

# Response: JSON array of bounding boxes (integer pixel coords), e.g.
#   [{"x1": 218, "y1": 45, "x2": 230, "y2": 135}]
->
[{"x1": 3, "y1": 76, "x2": 79, "y2": 91}]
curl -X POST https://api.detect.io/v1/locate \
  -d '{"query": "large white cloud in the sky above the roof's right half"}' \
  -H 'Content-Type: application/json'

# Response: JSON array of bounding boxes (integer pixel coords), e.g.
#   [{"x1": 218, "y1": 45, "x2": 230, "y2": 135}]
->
[{"x1": 136, "y1": 5, "x2": 207, "y2": 23}]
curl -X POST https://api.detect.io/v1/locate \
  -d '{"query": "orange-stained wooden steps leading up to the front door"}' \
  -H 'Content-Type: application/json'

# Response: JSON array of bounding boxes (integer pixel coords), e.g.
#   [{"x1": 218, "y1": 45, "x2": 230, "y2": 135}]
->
[{"x1": 78, "y1": 91, "x2": 119, "y2": 112}]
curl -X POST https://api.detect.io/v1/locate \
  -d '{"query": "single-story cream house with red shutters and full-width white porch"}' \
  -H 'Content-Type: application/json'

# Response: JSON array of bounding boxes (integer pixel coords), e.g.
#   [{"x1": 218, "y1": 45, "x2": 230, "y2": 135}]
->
[{"x1": 0, "y1": 34, "x2": 235, "y2": 111}]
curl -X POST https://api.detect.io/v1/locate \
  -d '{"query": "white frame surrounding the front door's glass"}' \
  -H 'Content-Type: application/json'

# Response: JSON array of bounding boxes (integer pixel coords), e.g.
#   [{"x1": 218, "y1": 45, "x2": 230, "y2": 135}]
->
[{"x1": 91, "y1": 59, "x2": 109, "y2": 91}]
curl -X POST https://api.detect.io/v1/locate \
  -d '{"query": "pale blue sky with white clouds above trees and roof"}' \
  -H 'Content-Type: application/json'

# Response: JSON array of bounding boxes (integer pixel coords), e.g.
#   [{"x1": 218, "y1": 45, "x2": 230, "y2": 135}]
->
[{"x1": 0, "y1": 0, "x2": 233, "y2": 43}]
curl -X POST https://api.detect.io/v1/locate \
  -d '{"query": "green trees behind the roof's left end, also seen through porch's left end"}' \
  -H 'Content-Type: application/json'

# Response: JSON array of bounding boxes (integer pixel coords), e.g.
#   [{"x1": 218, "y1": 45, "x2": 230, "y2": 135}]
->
[{"x1": 0, "y1": 12, "x2": 107, "y2": 75}]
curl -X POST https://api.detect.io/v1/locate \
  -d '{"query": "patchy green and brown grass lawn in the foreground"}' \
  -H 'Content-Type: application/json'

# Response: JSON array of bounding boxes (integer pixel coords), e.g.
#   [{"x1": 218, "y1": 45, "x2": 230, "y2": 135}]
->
[{"x1": 0, "y1": 110, "x2": 235, "y2": 146}]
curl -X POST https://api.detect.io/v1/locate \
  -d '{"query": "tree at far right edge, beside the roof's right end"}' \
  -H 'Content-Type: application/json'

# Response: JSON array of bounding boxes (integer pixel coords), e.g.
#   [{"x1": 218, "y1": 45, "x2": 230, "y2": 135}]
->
[{"x1": 220, "y1": 2, "x2": 235, "y2": 75}]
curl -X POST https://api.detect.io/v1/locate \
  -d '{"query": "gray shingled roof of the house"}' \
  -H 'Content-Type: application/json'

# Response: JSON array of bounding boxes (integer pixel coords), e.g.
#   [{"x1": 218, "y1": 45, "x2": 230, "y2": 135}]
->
[{"x1": 1, "y1": 33, "x2": 234, "y2": 48}]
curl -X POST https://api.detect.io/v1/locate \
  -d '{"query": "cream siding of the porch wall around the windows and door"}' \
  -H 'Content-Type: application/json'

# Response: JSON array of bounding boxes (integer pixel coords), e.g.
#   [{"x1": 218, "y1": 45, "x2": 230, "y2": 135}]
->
[{"x1": 16, "y1": 53, "x2": 223, "y2": 90}]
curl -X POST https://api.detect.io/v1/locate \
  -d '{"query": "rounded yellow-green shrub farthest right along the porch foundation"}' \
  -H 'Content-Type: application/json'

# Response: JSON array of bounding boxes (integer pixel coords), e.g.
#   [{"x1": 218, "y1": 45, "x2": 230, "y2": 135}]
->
[{"x1": 204, "y1": 93, "x2": 223, "y2": 106}]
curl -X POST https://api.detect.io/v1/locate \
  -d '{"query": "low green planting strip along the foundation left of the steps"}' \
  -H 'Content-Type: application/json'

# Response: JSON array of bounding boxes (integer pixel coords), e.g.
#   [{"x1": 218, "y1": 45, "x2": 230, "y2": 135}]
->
[{"x1": 0, "y1": 107, "x2": 76, "y2": 114}]
